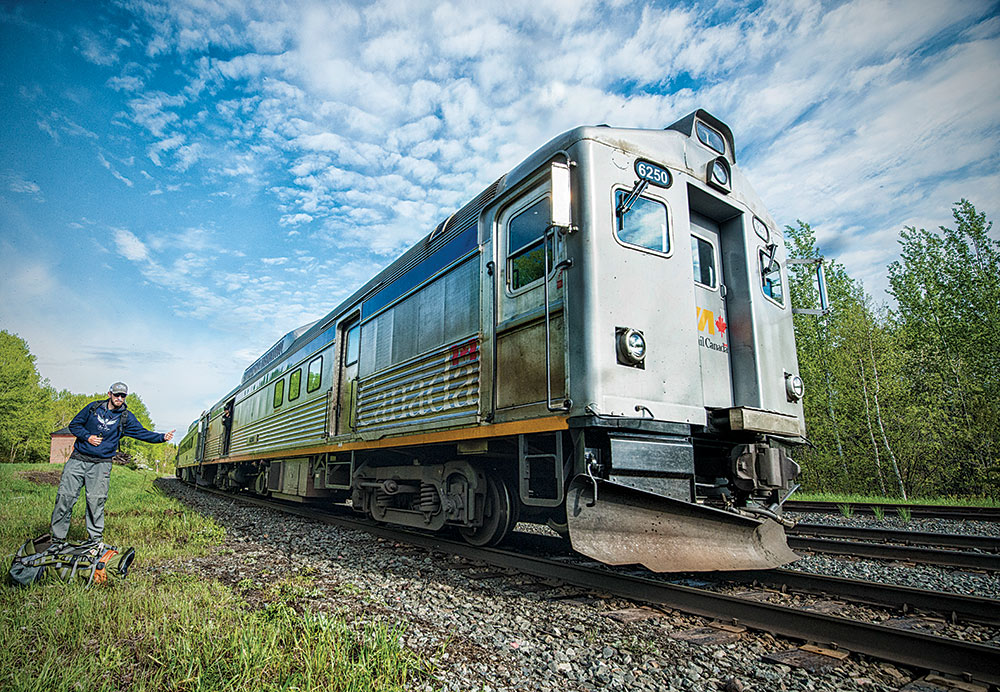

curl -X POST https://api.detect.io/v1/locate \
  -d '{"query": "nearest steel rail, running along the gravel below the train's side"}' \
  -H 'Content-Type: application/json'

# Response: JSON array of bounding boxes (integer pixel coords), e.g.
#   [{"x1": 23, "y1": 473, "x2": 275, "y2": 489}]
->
[{"x1": 180, "y1": 488, "x2": 1000, "y2": 685}]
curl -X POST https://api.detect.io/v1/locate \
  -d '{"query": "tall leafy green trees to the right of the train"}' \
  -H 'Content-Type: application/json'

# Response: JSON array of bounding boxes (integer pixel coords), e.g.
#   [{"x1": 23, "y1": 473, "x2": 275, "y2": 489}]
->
[{"x1": 786, "y1": 199, "x2": 1000, "y2": 499}]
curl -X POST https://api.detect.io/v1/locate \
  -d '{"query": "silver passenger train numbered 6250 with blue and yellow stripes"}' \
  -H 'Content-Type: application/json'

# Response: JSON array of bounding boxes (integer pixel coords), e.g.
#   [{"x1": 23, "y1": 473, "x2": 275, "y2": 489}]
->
[{"x1": 176, "y1": 109, "x2": 822, "y2": 572}]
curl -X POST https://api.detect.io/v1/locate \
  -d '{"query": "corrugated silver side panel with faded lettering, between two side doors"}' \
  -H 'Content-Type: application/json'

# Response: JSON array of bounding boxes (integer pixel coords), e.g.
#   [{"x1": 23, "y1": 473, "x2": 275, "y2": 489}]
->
[{"x1": 358, "y1": 337, "x2": 480, "y2": 432}]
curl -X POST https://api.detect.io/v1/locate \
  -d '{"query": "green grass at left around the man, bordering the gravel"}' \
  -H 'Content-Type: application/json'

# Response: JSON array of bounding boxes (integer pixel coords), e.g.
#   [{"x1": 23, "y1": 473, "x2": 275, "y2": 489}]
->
[{"x1": 0, "y1": 464, "x2": 432, "y2": 692}]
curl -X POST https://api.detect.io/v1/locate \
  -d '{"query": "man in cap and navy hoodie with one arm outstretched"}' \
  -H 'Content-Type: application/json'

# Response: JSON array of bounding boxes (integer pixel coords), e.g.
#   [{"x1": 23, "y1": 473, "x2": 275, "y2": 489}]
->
[{"x1": 52, "y1": 382, "x2": 174, "y2": 542}]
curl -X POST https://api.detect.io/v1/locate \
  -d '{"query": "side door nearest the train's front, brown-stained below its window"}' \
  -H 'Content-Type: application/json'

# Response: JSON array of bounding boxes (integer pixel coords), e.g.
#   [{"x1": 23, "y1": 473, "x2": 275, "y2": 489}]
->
[{"x1": 494, "y1": 181, "x2": 566, "y2": 410}]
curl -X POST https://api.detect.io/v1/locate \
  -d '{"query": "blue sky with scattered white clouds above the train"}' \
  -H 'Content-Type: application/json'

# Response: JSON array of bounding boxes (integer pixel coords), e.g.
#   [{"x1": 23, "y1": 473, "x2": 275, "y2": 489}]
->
[{"x1": 0, "y1": 0, "x2": 1000, "y2": 430}]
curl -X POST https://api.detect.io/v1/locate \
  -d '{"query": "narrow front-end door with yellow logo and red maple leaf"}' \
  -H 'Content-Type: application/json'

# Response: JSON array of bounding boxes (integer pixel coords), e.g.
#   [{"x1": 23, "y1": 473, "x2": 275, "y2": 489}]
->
[{"x1": 691, "y1": 212, "x2": 733, "y2": 408}]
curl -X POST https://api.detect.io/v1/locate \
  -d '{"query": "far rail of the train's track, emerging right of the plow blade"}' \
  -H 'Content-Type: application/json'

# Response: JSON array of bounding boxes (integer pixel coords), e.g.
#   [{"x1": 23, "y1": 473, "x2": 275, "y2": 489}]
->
[{"x1": 726, "y1": 569, "x2": 1000, "y2": 624}]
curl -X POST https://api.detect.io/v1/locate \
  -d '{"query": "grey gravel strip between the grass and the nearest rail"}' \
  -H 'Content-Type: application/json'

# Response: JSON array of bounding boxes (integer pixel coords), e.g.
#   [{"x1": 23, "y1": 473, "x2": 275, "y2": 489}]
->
[{"x1": 156, "y1": 479, "x2": 982, "y2": 692}]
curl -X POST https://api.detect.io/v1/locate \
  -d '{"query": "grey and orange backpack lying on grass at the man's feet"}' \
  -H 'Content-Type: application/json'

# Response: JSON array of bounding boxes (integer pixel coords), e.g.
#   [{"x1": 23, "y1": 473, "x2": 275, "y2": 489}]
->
[{"x1": 7, "y1": 534, "x2": 135, "y2": 587}]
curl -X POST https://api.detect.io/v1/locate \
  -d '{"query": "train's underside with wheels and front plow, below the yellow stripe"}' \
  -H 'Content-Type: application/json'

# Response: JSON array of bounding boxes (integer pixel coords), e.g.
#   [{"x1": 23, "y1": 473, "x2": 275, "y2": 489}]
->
[{"x1": 178, "y1": 417, "x2": 798, "y2": 572}]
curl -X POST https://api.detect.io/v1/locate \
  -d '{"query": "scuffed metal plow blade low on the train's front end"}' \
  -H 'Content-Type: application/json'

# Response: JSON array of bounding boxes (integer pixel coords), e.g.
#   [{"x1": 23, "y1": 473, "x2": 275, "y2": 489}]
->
[{"x1": 566, "y1": 475, "x2": 798, "y2": 572}]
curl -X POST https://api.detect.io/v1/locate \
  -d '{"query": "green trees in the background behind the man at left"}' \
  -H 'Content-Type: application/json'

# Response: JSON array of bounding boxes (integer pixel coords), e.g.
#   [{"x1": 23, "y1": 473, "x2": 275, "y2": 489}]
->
[{"x1": 0, "y1": 330, "x2": 177, "y2": 472}]
